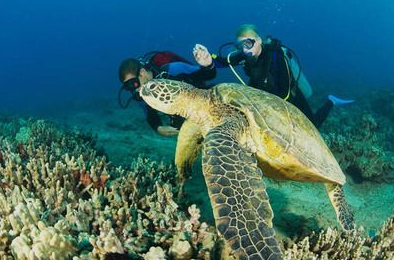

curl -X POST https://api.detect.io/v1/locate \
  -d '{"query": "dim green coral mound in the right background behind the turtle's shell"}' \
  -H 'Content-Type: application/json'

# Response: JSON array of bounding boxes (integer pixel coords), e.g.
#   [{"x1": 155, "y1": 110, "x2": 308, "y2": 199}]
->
[{"x1": 323, "y1": 108, "x2": 394, "y2": 182}]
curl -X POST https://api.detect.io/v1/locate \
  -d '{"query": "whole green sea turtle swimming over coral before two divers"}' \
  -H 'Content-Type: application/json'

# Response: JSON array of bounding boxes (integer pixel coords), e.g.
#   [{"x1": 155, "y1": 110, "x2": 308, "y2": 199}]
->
[{"x1": 140, "y1": 80, "x2": 353, "y2": 260}]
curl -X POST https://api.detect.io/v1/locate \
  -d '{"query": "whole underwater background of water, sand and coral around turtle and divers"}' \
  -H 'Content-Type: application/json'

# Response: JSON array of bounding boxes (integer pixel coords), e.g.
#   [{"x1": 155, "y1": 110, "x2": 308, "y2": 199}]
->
[{"x1": 0, "y1": 0, "x2": 394, "y2": 259}]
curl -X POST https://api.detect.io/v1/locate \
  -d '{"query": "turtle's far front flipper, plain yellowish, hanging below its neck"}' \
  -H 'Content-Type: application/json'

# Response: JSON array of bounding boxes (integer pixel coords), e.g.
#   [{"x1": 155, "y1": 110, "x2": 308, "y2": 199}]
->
[{"x1": 175, "y1": 120, "x2": 203, "y2": 197}]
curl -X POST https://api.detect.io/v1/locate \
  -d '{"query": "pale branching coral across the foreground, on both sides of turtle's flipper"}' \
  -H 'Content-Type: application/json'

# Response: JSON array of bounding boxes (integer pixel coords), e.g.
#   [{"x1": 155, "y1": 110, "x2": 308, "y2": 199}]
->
[{"x1": 0, "y1": 120, "x2": 394, "y2": 260}]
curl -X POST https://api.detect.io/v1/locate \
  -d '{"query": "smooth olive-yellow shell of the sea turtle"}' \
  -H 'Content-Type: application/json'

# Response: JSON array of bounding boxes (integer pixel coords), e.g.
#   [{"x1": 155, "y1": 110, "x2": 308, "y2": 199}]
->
[{"x1": 212, "y1": 83, "x2": 346, "y2": 184}]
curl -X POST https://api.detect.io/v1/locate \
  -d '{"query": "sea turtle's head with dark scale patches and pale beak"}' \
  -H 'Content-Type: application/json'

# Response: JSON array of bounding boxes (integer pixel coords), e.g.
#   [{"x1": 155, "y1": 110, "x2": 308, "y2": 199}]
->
[{"x1": 140, "y1": 79, "x2": 194, "y2": 115}]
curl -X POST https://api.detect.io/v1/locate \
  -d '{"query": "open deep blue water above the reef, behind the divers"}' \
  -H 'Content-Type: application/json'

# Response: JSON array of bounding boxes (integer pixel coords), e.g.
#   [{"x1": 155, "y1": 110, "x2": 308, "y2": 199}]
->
[{"x1": 0, "y1": 0, "x2": 394, "y2": 111}]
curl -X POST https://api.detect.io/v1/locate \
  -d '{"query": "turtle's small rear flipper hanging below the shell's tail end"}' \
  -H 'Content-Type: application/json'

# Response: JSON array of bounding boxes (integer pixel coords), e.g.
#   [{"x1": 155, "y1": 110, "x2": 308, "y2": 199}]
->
[{"x1": 324, "y1": 183, "x2": 354, "y2": 231}]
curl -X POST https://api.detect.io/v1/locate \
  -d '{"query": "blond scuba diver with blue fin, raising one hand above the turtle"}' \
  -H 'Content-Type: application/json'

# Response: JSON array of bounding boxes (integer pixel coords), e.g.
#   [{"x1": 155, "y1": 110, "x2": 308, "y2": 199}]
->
[{"x1": 195, "y1": 24, "x2": 354, "y2": 128}]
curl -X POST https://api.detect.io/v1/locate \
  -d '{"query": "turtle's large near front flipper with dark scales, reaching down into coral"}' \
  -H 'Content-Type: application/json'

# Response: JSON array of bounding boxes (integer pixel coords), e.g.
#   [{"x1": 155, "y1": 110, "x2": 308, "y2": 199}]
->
[{"x1": 202, "y1": 122, "x2": 282, "y2": 260}]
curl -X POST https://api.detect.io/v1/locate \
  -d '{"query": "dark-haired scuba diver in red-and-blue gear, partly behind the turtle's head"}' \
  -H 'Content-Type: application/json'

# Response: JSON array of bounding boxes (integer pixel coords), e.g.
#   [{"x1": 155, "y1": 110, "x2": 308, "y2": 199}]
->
[{"x1": 118, "y1": 50, "x2": 216, "y2": 136}]
